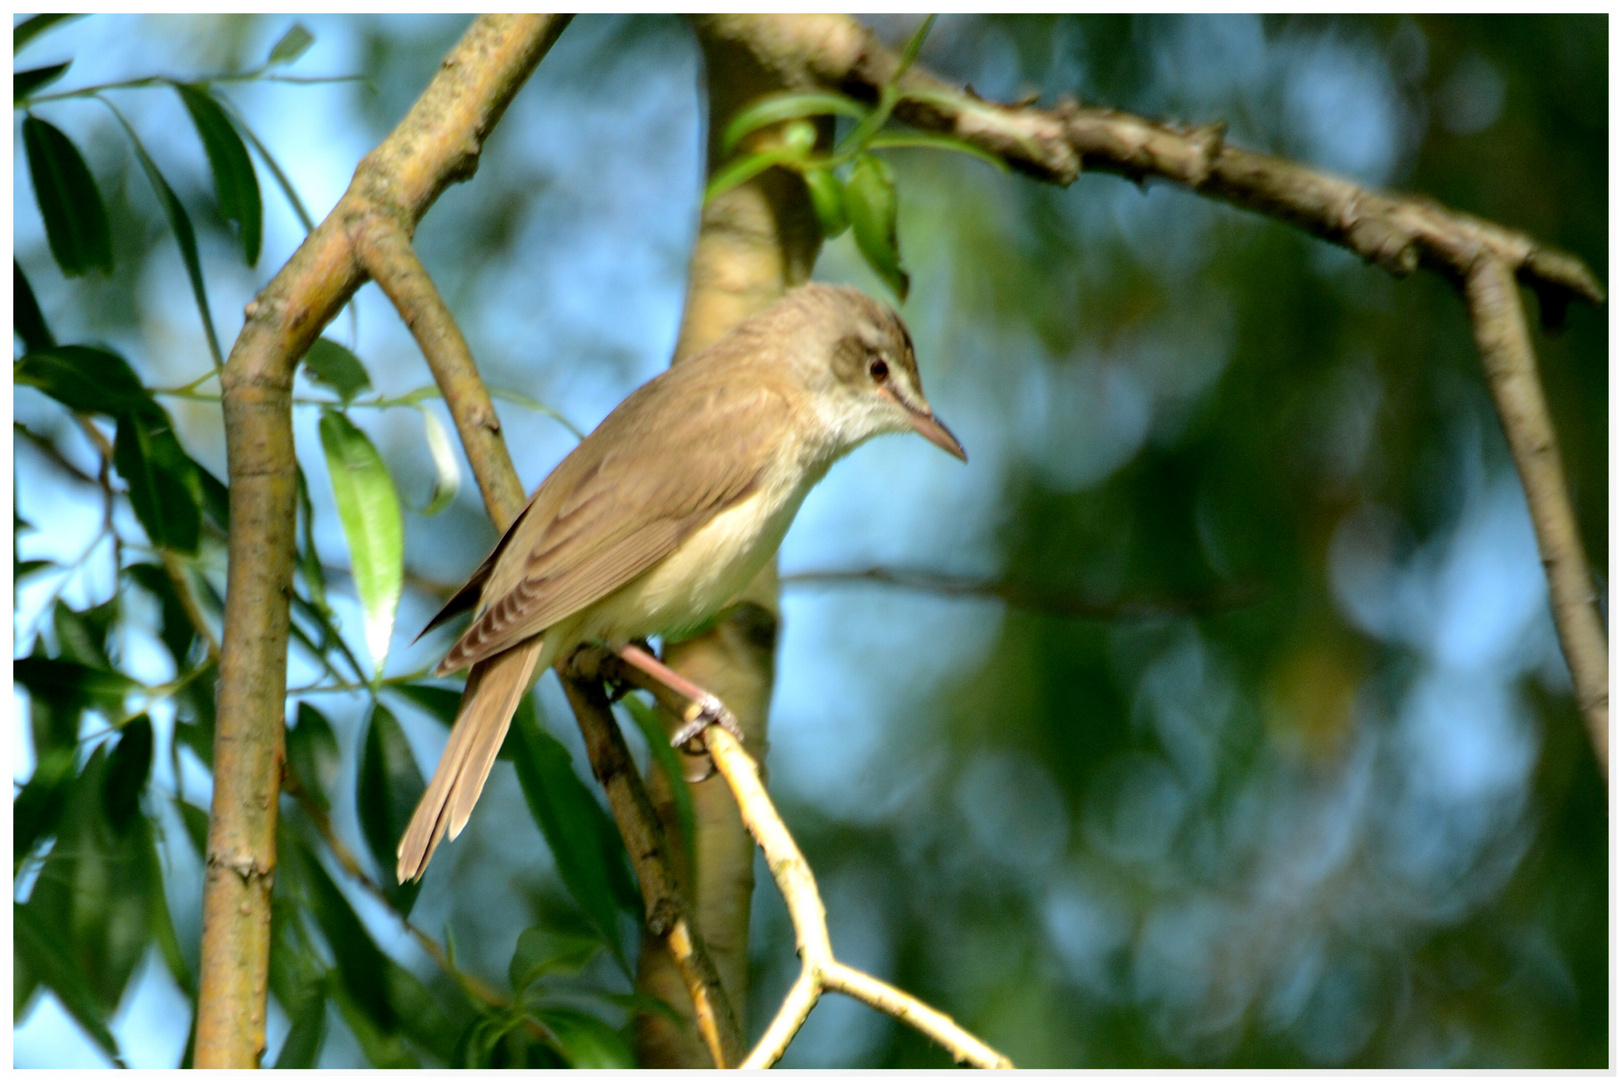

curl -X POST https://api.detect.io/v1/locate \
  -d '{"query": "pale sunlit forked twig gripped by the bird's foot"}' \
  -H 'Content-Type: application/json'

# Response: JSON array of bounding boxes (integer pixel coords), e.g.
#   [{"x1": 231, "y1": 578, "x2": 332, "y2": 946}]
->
[{"x1": 575, "y1": 648, "x2": 1012, "y2": 1069}]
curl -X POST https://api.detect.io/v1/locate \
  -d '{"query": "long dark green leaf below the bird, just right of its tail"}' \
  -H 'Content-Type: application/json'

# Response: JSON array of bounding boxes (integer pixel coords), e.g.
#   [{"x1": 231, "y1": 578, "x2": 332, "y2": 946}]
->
[{"x1": 507, "y1": 696, "x2": 641, "y2": 967}]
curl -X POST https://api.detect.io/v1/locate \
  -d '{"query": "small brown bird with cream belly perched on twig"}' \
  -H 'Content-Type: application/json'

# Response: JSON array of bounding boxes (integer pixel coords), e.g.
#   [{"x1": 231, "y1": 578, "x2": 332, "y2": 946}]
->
[{"x1": 397, "y1": 283, "x2": 967, "y2": 882}]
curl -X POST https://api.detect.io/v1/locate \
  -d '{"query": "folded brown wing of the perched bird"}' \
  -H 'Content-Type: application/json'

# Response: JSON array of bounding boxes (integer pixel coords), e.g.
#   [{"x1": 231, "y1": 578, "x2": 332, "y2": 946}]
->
[{"x1": 439, "y1": 368, "x2": 790, "y2": 674}]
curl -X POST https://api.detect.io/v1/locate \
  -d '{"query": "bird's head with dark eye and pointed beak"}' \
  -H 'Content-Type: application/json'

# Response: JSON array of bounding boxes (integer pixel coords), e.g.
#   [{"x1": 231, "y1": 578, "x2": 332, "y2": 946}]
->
[{"x1": 780, "y1": 285, "x2": 967, "y2": 461}]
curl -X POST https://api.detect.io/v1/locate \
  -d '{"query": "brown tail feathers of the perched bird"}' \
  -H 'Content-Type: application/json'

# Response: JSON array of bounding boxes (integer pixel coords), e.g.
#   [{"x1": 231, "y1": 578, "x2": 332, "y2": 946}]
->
[{"x1": 398, "y1": 636, "x2": 544, "y2": 882}]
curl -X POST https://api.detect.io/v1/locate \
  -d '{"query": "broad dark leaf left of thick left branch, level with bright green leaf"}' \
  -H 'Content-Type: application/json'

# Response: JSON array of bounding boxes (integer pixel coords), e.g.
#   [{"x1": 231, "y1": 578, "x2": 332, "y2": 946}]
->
[{"x1": 112, "y1": 413, "x2": 202, "y2": 555}]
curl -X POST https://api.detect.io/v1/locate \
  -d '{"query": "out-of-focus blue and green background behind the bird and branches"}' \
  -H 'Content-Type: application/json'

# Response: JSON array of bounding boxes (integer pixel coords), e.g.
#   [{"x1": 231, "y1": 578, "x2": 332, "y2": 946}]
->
[{"x1": 13, "y1": 15, "x2": 1609, "y2": 1067}]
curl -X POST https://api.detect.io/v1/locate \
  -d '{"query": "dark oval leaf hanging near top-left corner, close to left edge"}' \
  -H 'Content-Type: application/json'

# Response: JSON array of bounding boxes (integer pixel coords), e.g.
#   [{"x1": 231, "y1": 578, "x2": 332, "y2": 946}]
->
[{"x1": 23, "y1": 115, "x2": 112, "y2": 277}]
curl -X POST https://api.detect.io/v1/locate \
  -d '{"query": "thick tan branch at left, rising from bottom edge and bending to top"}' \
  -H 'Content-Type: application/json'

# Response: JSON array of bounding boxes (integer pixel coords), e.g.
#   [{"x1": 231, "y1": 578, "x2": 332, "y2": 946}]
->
[{"x1": 194, "y1": 15, "x2": 567, "y2": 1069}]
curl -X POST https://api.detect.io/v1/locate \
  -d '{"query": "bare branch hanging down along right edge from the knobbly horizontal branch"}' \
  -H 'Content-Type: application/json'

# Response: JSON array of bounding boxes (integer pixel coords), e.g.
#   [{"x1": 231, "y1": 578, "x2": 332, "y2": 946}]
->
[{"x1": 1465, "y1": 253, "x2": 1608, "y2": 777}]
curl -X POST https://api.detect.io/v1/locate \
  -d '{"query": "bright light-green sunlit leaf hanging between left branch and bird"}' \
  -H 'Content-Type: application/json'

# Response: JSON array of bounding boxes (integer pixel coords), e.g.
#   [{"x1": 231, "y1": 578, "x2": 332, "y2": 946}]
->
[{"x1": 321, "y1": 410, "x2": 405, "y2": 677}]
